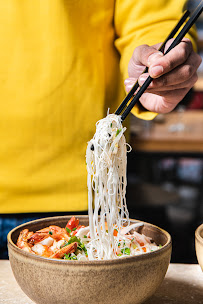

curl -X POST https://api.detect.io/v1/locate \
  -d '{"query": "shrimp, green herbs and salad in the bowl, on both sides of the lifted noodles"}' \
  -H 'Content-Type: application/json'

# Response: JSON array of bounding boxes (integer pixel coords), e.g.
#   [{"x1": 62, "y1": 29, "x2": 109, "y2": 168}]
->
[{"x1": 17, "y1": 216, "x2": 161, "y2": 261}]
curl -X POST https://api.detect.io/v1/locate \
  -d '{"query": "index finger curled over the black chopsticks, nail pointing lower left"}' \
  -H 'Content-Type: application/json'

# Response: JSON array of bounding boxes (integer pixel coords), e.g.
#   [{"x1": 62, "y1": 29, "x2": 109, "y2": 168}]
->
[{"x1": 149, "y1": 38, "x2": 193, "y2": 78}]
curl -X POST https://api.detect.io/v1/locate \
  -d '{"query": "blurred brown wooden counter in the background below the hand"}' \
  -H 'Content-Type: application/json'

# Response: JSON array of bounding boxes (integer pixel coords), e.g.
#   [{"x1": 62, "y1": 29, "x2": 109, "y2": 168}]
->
[{"x1": 130, "y1": 110, "x2": 203, "y2": 153}]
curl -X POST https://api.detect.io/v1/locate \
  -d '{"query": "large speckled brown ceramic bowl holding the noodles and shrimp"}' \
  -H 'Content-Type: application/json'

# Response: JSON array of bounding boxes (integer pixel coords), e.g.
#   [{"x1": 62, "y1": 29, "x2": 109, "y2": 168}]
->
[{"x1": 8, "y1": 216, "x2": 172, "y2": 304}]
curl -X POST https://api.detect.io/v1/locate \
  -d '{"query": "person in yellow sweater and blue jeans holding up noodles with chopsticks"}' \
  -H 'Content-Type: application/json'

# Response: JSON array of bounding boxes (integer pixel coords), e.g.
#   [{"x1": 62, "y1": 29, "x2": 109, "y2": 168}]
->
[{"x1": 0, "y1": 0, "x2": 201, "y2": 257}]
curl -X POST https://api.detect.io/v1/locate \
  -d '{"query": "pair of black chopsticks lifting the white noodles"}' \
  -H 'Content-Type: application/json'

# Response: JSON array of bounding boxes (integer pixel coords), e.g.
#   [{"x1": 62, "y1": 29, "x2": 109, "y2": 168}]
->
[{"x1": 115, "y1": 1, "x2": 203, "y2": 121}]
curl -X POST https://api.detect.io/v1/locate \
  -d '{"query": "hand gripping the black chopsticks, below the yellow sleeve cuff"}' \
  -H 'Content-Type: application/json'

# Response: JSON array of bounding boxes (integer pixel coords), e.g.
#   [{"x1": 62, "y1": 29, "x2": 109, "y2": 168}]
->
[{"x1": 124, "y1": 38, "x2": 202, "y2": 113}]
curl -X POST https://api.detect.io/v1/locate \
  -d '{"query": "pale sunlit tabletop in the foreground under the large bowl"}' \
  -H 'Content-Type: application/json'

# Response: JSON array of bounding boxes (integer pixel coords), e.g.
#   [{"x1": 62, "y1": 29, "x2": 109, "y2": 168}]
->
[{"x1": 0, "y1": 260, "x2": 203, "y2": 304}]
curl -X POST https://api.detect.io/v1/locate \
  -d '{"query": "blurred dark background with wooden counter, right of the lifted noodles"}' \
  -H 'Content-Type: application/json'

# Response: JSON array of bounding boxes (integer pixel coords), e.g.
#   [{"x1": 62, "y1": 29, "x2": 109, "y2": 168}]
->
[{"x1": 127, "y1": 0, "x2": 203, "y2": 263}]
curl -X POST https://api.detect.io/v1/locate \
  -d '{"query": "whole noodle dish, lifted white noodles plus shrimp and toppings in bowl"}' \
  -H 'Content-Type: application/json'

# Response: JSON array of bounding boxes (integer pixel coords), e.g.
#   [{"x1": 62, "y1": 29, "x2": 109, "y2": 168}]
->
[{"x1": 17, "y1": 114, "x2": 162, "y2": 260}]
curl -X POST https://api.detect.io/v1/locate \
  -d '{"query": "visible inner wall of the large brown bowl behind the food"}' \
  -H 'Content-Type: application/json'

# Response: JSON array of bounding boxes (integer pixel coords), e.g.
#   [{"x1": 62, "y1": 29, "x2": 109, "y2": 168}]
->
[{"x1": 8, "y1": 215, "x2": 171, "y2": 251}]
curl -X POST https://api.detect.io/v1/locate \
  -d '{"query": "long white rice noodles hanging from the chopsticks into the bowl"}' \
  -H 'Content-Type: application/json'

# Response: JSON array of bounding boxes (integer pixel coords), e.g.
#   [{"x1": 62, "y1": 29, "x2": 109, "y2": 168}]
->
[{"x1": 86, "y1": 114, "x2": 129, "y2": 260}]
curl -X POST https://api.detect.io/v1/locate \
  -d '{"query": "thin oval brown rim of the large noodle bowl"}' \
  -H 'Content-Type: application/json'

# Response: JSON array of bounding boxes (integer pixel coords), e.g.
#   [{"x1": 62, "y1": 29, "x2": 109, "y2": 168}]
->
[{"x1": 7, "y1": 215, "x2": 172, "y2": 266}]
